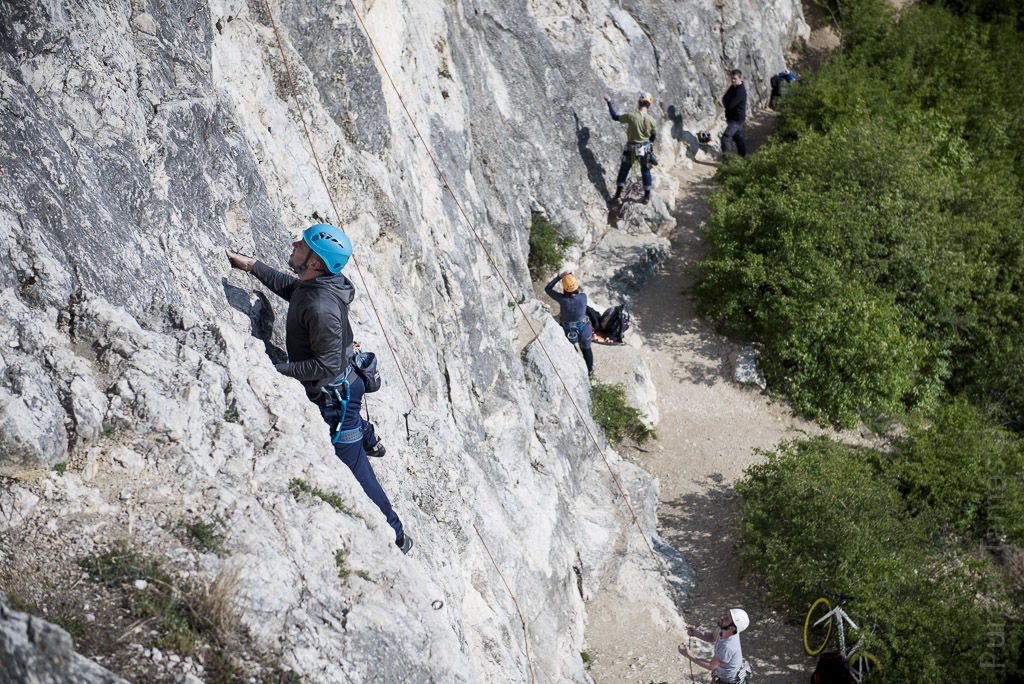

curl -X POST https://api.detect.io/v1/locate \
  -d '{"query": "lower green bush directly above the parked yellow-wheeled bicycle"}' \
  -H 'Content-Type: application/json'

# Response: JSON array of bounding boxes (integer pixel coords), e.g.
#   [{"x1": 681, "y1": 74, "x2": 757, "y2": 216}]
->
[{"x1": 736, "y1": 433, "x2": 1022, "y2": 682}]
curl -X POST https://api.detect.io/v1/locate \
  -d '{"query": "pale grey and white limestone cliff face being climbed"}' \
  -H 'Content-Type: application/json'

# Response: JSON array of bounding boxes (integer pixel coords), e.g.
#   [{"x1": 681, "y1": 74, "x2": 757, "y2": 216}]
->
[{"x1": 0, "y1": 0, "x2": 806, "y2": 682}]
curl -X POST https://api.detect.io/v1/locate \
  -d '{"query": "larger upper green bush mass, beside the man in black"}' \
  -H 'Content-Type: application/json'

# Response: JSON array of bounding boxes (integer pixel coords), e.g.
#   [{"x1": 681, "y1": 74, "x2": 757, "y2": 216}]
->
[{"x1": 696, "y1": 0, "x2": 1024, "y2": 429}]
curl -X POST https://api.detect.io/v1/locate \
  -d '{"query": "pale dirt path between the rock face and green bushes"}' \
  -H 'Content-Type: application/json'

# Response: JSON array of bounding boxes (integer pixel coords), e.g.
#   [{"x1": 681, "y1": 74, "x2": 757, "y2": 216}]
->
[{"x1": 587, "y1": 114, "x2": 847, "y2": 684}]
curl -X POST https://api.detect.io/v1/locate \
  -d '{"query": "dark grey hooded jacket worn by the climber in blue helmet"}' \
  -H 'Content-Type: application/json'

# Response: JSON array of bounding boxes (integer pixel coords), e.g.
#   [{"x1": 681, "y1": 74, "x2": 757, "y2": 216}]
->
[{"x1": 252, "y1": 261, "x2": 355, "y2": 398}]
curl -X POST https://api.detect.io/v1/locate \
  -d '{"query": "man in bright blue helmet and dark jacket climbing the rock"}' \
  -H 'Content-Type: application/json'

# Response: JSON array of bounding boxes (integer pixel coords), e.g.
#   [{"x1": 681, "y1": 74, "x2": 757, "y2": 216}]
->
[{"x1": 226, "y1": 223, "x2": 413, "y2": 553}]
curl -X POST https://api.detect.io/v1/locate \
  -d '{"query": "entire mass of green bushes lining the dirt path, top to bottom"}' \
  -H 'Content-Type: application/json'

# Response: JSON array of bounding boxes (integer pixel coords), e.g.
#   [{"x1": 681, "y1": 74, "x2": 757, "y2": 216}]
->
[{"x1": 720, "y1": 0, "x2": 1024, "y2": 682}]
